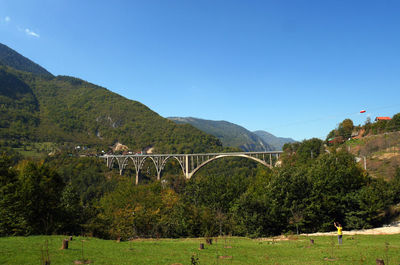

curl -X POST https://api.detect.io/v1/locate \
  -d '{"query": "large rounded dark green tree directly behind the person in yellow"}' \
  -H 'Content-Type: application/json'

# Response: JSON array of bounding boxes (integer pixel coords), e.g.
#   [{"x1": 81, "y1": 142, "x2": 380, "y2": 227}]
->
[{"x1": 308, "y1": 151, "x2": 368, "y2": 231}]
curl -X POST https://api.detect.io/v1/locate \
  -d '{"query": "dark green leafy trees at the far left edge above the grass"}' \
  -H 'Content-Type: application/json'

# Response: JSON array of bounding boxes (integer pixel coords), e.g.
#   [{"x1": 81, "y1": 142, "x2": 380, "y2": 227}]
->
[{"x1": 0, "y1": 155, "x2": 64, "y2": 235}]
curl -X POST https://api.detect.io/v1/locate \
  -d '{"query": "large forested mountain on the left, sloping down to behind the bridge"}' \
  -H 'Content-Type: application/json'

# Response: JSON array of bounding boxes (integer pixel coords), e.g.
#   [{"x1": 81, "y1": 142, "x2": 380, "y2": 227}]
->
[{"x1": 0, "y1": 45, "x2": 222, "y2": 153}]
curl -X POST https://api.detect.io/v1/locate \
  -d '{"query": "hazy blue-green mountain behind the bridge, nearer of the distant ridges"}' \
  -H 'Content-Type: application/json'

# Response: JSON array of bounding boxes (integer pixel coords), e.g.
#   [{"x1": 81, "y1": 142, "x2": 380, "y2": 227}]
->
[{"x1": 168, "y1": 117, "x2": 274, "y2": 151}]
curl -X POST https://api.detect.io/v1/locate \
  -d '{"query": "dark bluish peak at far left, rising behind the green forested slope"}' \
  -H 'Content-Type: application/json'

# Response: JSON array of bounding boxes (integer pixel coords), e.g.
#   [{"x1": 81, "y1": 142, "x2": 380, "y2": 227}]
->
[{"x1": 0, "y1": 43, "x2": 52, "y2": 76}]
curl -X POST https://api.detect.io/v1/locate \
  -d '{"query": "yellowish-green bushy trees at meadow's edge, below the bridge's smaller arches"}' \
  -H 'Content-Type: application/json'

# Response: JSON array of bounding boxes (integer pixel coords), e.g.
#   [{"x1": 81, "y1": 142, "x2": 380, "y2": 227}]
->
[{"x1": 101, "y1": 179, "x2": 187, "y2": 239}]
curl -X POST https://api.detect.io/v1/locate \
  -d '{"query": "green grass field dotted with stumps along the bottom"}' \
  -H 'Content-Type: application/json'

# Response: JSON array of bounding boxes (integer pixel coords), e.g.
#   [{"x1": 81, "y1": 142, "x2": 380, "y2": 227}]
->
[{"x1": 0, "y1": 235, "x2": 400, "y2": 265}]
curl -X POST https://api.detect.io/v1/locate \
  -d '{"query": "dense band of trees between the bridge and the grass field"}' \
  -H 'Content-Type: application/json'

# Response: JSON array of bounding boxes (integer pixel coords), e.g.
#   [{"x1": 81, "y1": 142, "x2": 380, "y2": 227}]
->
[{"x1": 0, "y1": 139, "x2": 400, "y2": 239}]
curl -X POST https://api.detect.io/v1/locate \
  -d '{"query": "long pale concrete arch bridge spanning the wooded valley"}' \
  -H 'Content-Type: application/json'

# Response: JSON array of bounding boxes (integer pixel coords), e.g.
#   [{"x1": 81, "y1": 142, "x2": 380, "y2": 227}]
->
[{"x1": 100, "y1": 151, "x2": 282, "y2": 184}]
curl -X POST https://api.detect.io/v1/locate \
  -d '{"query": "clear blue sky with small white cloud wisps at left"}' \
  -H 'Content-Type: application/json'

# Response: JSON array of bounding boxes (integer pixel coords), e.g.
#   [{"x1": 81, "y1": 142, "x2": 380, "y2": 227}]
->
[{"x1": 0, "y1": 0, "x2": 400, "y2": 140}]
